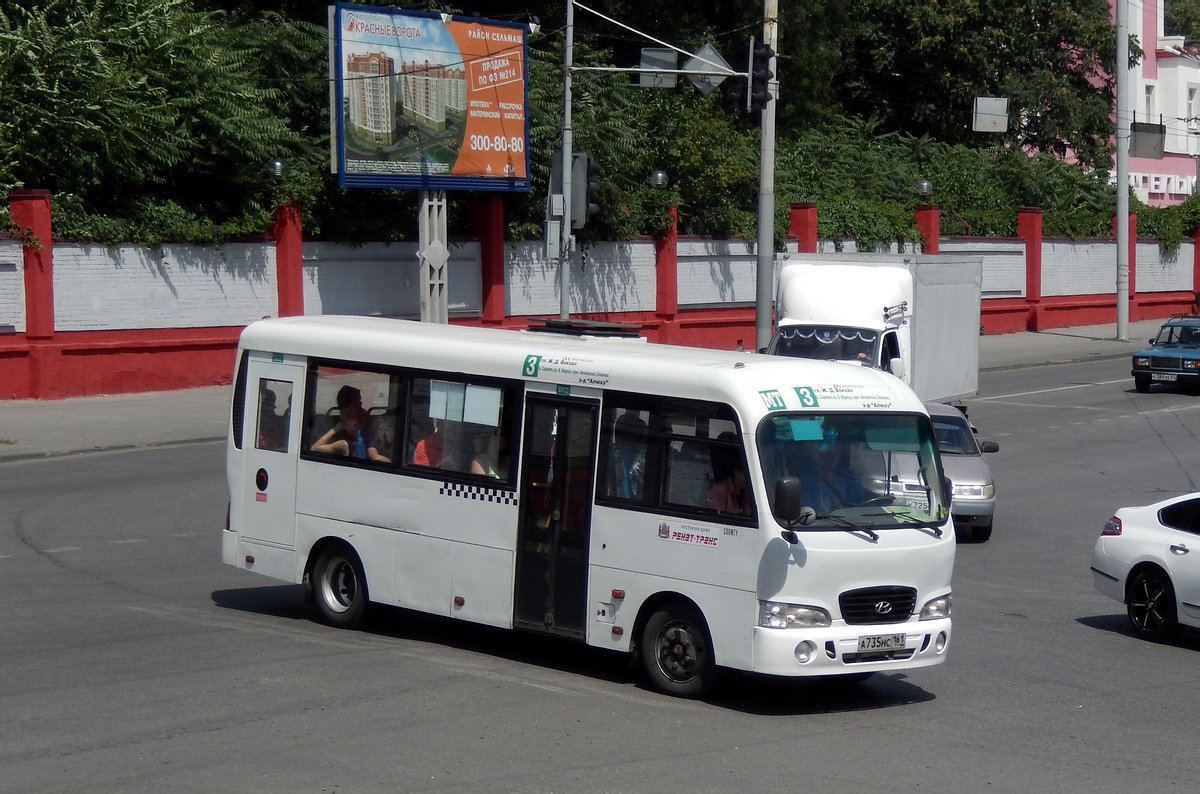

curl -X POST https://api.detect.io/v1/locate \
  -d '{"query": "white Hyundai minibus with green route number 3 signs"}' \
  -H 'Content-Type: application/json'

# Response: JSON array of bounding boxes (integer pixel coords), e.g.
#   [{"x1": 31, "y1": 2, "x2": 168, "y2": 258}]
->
[{"x1": 222, "y1": 317, "x2": 955, "y2": 697}]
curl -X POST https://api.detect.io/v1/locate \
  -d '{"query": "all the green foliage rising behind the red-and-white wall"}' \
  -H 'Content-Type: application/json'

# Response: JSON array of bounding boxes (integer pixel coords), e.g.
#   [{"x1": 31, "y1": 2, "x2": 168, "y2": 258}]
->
[{"x1": 0, "y1": 0, "x2": 1200, "y2": 255}]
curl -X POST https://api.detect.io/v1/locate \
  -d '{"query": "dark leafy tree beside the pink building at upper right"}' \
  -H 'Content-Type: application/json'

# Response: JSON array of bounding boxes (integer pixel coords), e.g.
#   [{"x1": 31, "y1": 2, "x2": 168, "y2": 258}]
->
[{"x1": 835, "y1": 0, "x2": 1116, "y2": 168}]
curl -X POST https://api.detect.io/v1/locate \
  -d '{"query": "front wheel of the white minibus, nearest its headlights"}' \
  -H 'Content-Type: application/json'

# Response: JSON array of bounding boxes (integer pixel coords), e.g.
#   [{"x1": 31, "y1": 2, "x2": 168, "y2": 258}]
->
[{"x1": 640, "y1": 601, "x2": 716, "y2": 698}]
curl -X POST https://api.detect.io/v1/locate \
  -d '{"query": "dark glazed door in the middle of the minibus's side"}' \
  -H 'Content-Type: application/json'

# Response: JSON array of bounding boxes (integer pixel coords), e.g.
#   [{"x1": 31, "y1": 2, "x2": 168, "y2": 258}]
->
[{"x1": 514, "y1": 395, "x2": 599, "y2": 638}]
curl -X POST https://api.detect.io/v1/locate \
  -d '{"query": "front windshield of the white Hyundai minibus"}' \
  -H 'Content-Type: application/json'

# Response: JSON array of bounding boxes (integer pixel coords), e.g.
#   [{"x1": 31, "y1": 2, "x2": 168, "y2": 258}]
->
[{"x1": 757, "y1": 413, "x2": 950, "y2": 530}]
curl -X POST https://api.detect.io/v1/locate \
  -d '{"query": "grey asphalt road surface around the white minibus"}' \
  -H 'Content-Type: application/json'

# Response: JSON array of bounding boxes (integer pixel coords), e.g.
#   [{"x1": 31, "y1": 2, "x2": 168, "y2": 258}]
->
[{"x1": 0, "y1": 360, "x2": 1200, "y2": 794}]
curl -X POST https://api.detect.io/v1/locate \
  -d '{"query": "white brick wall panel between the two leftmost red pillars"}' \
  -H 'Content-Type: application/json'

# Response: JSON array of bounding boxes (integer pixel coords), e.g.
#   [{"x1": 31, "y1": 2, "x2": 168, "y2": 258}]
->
[{"x1": 54, "y1": 243, "x2": 278, "y2": 331}]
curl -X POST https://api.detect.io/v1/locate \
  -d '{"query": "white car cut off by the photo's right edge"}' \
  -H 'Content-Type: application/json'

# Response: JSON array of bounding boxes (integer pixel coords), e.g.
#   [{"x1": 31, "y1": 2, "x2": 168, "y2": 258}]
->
[{"x1": 1092, "y1": 493, "x2": 1200, "y2": 642}]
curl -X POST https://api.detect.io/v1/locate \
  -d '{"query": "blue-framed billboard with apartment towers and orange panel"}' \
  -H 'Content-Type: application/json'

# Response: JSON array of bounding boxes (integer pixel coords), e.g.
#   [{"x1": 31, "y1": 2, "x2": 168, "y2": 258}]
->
[{"x1": 330, "y1": 4, "x2": 529, "y2": 192}]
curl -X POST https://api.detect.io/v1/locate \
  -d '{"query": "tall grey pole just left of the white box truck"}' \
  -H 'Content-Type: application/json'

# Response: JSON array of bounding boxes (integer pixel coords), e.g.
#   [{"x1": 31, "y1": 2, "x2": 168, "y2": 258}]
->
[{"x1": 755, "y1": 0, "x2": 779, "y2": 350}]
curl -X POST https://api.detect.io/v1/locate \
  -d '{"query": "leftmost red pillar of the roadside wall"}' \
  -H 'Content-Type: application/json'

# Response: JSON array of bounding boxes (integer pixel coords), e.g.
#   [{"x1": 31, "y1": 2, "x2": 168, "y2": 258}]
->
[{"x1": 8, "y1": 190, "x2": 54, "y2": 339}]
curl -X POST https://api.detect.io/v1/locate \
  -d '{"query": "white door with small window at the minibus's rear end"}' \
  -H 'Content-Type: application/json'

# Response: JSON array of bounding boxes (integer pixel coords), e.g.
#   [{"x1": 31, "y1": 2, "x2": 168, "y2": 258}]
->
[{"x1": 238, "y1": 354, "x2": 305, "y2": 546}]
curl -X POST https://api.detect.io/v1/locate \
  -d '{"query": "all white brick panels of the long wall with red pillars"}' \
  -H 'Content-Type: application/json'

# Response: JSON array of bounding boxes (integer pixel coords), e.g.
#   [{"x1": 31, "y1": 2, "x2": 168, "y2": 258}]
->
[{"x1": 14, "y1": 231, "x2": 1200, "y2": 335}]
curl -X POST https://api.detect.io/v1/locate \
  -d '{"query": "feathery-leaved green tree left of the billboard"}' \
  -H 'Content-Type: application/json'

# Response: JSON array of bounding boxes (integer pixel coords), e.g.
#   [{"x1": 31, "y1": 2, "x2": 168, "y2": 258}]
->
[{"x1": 0, "y1": 0, "x2": 302, "y2": 237}]
